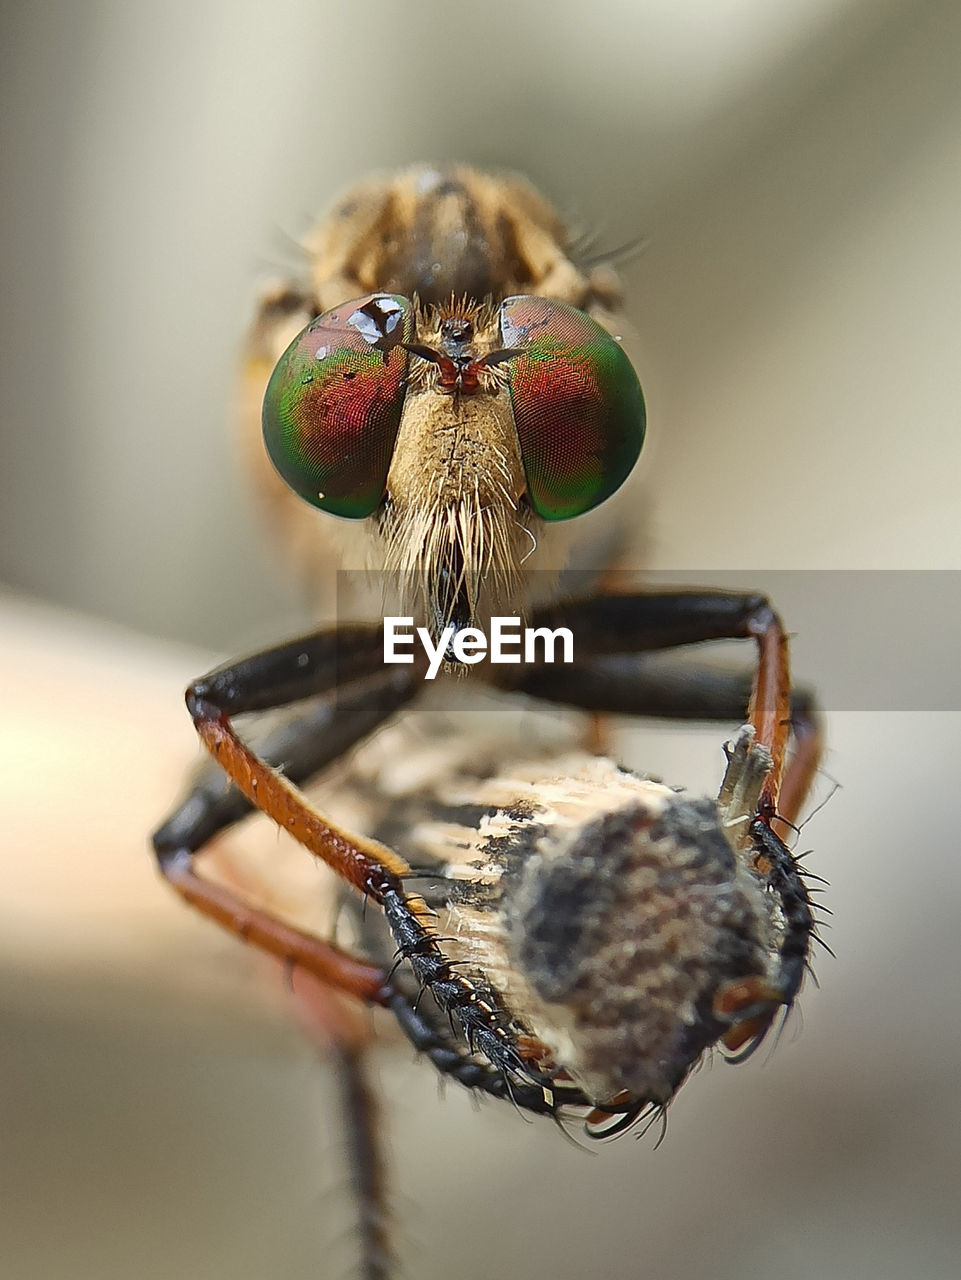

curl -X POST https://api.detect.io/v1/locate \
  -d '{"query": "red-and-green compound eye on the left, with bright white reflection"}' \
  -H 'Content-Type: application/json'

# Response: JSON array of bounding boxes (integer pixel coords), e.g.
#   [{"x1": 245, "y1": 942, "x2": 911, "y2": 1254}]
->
[{"x1": 264, "y1": 293, "x2": 413, "y2": 520}]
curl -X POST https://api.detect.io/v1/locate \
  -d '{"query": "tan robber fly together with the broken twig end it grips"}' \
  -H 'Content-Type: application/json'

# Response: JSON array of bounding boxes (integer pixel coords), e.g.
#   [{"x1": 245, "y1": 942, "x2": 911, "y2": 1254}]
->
[{"x1": 154, "y1": 168, "x2": 819, "y2": 1276}]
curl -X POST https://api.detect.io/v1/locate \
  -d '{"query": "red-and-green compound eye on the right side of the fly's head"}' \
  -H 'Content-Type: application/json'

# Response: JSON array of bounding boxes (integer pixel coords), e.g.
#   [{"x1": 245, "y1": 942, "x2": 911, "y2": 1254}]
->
[{"x1": 500, "y1": 297, "x2": 646, "y2": 520}]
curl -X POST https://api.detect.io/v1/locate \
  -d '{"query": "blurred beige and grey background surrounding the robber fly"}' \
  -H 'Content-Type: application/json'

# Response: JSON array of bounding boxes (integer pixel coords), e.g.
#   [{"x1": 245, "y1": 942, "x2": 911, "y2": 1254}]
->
[{"x1": 0, "y1": 0, "x2": 961, "y2": 1280}]
